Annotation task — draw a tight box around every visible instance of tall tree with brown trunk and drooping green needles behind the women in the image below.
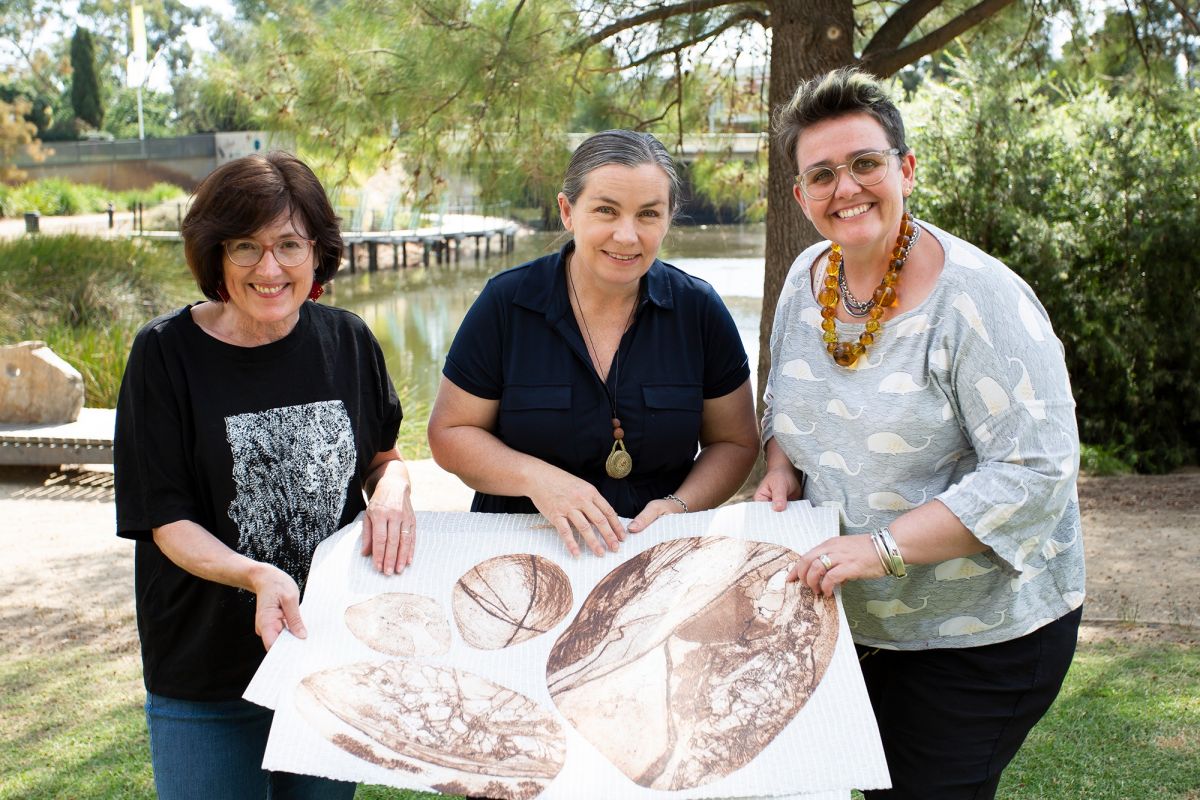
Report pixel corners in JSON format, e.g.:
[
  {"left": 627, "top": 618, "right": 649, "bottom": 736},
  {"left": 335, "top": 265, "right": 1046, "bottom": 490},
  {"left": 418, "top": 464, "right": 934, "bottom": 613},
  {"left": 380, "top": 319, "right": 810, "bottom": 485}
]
[{"left": 218, "top": 0, "right": 1161, "bottom": 410}]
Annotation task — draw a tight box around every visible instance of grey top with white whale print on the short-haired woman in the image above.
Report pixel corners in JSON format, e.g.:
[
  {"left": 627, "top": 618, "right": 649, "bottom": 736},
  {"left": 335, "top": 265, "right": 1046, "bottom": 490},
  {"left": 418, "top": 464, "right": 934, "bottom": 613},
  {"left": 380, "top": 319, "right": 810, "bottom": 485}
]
[{"left": 763, "top": 222, "right": 1084, "bottom": 650}]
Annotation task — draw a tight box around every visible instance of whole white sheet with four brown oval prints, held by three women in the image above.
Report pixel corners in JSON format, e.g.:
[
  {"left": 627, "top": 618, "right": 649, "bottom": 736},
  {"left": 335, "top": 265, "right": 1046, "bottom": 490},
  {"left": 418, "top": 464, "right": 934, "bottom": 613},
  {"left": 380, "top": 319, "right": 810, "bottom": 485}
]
[{"left": 246, "top": 504, "right": 887, "bottom": 800}]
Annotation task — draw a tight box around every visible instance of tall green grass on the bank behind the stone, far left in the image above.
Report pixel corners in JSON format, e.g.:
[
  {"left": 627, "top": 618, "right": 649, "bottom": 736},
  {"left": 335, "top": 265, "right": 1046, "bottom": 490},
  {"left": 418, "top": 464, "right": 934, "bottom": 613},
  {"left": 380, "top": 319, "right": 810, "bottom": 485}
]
[{"left": 0, "top": 235, "right": 196, "bottom": 408}]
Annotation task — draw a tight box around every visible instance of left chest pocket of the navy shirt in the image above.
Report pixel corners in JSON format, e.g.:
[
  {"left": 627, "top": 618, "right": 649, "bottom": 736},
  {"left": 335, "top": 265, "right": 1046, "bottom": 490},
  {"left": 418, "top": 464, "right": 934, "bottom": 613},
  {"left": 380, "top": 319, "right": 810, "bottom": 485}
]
[{"left": 497, "top": 384, "right": 574, "bottom": 464}]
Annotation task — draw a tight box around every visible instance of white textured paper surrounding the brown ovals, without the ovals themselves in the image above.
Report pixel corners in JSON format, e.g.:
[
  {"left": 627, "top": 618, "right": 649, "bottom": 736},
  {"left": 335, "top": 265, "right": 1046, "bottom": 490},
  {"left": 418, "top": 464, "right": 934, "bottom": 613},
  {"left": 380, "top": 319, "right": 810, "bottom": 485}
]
[{"left": 245, "top": 501, "right": 890, "bottom": 800}]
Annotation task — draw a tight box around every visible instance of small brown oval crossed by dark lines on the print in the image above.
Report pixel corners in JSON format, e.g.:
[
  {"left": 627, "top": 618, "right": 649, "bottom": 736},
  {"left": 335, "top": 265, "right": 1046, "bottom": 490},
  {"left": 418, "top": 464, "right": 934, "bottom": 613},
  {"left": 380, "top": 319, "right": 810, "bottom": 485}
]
[{"left": 454, "top": 553, "right": 574, "bottom": 650}]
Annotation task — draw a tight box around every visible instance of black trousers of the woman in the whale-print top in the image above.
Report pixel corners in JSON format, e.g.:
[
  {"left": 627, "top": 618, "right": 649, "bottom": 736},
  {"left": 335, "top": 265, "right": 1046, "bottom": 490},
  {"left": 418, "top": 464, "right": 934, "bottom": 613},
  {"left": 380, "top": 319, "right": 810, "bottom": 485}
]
[{"left": 858, "top": 608, "right": 1082, "bottom": 800}]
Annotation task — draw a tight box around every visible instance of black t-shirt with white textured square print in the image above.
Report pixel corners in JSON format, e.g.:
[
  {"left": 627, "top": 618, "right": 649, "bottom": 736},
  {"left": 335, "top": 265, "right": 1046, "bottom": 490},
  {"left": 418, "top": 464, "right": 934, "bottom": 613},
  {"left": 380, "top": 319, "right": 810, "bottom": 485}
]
[{"left": 114, "top": 302, "right": 402, "bottom": 700}]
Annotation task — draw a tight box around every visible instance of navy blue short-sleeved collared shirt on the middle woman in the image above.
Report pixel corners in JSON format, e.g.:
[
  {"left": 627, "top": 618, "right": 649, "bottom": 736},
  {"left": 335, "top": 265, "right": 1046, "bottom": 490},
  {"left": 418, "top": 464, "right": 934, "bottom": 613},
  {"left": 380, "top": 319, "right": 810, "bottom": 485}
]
[{"left": 443, "top": 242, "right": 750, "bottom": 517}]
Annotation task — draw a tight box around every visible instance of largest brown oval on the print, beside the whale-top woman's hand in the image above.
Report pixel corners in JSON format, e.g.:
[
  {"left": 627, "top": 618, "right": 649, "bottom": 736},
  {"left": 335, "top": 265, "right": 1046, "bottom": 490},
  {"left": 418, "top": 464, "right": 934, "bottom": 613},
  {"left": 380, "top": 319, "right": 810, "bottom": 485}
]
[{"left": 546, "top": 536, "right": 838, "bottom": 790}]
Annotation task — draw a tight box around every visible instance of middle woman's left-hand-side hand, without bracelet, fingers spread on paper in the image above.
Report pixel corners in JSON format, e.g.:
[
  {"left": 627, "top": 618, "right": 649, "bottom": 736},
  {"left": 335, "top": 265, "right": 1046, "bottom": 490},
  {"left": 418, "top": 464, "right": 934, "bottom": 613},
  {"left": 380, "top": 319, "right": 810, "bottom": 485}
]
[{"left": 529, "top": 465, "right": 625, "bottom": 557}]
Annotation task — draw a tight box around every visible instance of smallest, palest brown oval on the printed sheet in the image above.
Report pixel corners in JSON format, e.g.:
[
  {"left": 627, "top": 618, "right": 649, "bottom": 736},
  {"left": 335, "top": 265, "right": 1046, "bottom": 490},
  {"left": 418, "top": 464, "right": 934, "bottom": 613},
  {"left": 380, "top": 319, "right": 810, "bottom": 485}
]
[{"left": 346, "top": 591, "right": 450, "bottom": 657}]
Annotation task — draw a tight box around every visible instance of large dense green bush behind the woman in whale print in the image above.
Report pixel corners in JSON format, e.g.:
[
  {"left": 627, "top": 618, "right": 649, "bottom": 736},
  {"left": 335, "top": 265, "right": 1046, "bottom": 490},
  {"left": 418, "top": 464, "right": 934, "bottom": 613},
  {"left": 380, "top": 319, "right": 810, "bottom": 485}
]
[{"left": 905, "top": 54, "right": 1200, "bottom": 471}]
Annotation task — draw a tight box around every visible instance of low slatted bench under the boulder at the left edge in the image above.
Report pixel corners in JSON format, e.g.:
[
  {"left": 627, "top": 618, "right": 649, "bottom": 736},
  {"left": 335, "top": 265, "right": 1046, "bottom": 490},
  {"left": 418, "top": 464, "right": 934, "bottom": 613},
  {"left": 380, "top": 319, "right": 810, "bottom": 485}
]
[{"left": 0, "top": 408, "right": 116, "bottom": 467}]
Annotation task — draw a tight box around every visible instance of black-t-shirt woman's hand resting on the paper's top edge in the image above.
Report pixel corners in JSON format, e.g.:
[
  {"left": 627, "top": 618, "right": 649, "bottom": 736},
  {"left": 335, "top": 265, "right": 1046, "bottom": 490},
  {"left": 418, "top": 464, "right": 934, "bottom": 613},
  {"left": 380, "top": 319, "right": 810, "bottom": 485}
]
[{"left": 362, "top": 450, "right": 416, "bottom": 575}]
